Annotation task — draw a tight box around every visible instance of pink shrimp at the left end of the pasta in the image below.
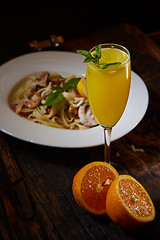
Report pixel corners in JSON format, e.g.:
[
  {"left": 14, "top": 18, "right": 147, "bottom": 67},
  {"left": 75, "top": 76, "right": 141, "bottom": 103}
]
[{"left": 23, "top": 94, "right": 41, "bottom": 108}]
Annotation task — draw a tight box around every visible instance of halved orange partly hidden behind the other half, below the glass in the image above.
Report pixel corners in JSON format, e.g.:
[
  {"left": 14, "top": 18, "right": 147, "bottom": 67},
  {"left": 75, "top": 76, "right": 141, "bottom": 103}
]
[{"left": 72, "top": 161, "right": 119, "bottom": 215}]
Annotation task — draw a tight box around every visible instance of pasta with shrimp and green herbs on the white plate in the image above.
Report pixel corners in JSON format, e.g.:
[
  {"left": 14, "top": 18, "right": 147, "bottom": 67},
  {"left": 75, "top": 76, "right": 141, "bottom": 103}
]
[{"left": 9, "top": 71, "right": 97, "bottom": 130}]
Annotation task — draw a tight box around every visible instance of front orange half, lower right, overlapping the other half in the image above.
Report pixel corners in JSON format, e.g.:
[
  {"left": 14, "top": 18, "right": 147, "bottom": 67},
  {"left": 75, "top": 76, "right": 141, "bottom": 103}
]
[{"left": 106, "top": 175, "right": 155, "bottom": 229}]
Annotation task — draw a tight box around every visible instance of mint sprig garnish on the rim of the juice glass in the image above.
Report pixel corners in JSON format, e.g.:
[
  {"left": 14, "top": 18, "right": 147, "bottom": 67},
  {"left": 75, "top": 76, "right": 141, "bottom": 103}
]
[{"left": 77, "top": 44, "right": 121, "bottom": 69}]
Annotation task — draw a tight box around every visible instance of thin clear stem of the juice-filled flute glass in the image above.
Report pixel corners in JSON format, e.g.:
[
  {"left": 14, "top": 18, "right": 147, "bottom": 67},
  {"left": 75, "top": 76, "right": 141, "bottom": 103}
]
[{"left": 104, "top": 127, "right": 112, "bottom": 164}]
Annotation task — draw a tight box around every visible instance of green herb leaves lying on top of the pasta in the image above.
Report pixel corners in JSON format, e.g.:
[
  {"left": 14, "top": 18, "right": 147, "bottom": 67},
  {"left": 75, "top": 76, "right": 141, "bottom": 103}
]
[{"left": 44, "top": 78, "right": 81, "bottom": 106}]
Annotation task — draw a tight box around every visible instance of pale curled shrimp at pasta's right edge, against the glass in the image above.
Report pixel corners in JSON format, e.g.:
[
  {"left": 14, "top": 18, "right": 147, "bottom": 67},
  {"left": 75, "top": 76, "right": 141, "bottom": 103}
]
[{"left": 78, "top": 101, "right": 98, "bottom": 127}]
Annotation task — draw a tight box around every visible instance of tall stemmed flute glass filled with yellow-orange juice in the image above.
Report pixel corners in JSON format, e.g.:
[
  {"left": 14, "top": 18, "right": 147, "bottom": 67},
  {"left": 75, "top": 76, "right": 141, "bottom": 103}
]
[{"left": 86, "top": 43, "right": 131, "bottom": 164}]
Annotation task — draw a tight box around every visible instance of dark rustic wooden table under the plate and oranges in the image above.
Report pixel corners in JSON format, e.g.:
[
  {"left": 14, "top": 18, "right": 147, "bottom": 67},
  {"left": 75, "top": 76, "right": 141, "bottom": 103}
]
[{"left": 0, "top": 24, "right": 160, "bottom": 240}]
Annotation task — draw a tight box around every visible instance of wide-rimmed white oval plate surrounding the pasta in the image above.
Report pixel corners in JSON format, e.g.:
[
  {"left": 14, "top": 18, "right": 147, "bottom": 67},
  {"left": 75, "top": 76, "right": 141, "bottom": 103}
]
[{"left": 0, "top": 51, "right": 149, "bottom": 148}]
